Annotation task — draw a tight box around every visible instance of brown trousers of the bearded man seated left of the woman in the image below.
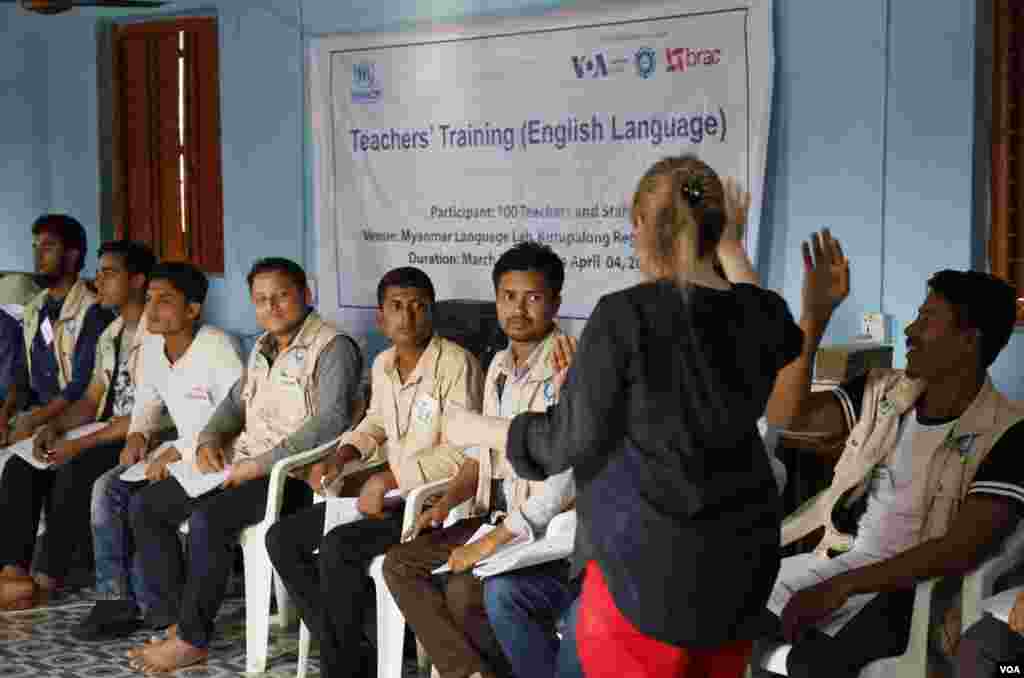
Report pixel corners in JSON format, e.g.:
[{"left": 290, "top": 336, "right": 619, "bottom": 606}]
[{"left": 384, "top": 518, "right": 512, "bottom": 678}]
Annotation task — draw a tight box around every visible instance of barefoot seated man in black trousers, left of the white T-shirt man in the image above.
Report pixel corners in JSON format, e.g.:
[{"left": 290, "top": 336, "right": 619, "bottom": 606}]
[{"left": 0, "top": 241, "right": 155, "bottom": 607}]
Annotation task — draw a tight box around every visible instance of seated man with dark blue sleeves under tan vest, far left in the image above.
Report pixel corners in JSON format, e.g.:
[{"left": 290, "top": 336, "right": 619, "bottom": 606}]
[{"left": 6, "top": 214, "right": 114, "bottom": 443}]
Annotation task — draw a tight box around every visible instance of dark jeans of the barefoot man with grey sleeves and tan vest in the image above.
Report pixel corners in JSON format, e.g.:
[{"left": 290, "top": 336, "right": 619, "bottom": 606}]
[{"left": 129, "top": 477, "right": 312, "bottom": 647}]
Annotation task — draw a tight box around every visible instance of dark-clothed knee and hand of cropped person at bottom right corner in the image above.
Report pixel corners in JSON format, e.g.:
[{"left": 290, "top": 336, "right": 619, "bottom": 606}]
[{"left": 955, "top": 570, "right": 1024, "bottom": 678}]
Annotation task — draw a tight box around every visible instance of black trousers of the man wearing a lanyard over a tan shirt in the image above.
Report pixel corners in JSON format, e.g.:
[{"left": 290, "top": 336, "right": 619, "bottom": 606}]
[{"left": 266, "top": 504, "right": 402, "bottom": 678}]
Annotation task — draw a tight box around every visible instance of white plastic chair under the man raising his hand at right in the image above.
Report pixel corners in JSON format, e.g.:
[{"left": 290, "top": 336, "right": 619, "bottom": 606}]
[{"left": 751, "top": 522, "right": 1024, "bottom": 678}]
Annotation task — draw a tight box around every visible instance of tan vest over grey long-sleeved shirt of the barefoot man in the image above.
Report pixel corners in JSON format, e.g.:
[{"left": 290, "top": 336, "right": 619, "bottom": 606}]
[{"left": 231, "top": 310, "right": 341, "bottom": 457}]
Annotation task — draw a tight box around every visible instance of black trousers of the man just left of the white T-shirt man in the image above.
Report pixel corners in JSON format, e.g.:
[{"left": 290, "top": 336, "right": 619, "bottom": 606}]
[{"left": 0, "top": 442, "right": 122, "bottom": 579}]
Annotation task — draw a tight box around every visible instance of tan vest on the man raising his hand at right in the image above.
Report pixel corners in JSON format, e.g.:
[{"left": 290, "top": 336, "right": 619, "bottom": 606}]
[{"left": 781, "top": 370, "right": 1024, "bottom": 557}]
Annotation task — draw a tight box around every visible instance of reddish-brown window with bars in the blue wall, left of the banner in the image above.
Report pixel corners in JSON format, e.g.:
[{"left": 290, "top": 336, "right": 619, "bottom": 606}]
[{"left": 113, "top": 17, "right": 224, "bottom": 273}]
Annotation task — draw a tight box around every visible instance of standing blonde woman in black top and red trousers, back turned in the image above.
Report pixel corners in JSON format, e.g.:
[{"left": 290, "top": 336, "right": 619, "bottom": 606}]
[{"left": 450, "top": 156, "right": 803, "bottom": 678}]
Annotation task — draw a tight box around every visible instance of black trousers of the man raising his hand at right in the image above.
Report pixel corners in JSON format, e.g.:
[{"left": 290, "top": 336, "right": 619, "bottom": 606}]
[{"left": 754, "top": 589, "right": 913, "bottom": 678}]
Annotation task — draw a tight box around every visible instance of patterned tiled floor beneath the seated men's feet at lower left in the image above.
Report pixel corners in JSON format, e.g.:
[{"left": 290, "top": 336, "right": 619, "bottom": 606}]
[{"left": 0, "top": 594, "right": 416, "bottom": 678}]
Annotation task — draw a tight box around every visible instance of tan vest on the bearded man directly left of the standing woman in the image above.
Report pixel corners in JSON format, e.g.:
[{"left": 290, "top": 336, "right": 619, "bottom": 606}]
[{"left": 473, "top": 327, "right": 562, "bottom": 514}]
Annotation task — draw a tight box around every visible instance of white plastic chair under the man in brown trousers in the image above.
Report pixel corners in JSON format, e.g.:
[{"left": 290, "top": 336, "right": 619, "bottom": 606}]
[{"left": 297, "top": 478, "right": 471, "bottom": 678}]
